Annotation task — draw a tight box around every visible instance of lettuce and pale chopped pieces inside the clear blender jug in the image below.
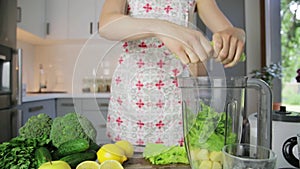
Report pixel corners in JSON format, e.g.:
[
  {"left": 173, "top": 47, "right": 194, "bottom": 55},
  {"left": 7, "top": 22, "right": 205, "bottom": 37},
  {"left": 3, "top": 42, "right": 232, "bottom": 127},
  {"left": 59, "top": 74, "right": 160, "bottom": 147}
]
[{"left": 185, "top": 103, "right": 237, "bottom": 169}]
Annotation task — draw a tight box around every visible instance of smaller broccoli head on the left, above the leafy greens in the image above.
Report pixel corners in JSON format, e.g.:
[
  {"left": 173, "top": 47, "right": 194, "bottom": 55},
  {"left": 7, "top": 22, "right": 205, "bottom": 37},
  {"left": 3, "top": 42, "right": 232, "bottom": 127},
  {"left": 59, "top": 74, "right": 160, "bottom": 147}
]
[{"left": 19, "top": 113, "right": 53, "bottom": 144}]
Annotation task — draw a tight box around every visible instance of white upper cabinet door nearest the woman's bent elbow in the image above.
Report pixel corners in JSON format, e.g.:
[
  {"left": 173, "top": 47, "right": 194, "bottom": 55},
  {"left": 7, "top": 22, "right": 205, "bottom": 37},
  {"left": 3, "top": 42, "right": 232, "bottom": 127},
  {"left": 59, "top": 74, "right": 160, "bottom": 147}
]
[{"left": 68, "top": 0, "right": 96, "bottom": 39}]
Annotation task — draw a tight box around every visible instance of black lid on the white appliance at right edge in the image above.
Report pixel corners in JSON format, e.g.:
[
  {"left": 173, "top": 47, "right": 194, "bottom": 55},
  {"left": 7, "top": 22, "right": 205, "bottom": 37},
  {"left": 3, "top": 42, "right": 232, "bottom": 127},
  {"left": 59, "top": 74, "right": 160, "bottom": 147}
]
[{"left": 273, "top": 106, "right": 300, "bottom": 122}]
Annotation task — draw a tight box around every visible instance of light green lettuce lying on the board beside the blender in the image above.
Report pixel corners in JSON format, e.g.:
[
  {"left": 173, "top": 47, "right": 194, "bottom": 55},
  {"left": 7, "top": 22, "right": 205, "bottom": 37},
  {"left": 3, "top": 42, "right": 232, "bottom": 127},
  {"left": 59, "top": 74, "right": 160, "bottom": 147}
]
[{"left": 143, "top": 143, "right": 189, "bottom": 164}]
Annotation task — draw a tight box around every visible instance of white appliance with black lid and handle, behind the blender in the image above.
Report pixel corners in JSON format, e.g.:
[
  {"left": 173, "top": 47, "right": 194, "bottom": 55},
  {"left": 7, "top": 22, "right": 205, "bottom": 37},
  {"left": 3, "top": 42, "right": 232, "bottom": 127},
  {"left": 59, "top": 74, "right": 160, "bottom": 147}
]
[{"left": 249, "top": 106, "right": 300, "bottom": 168}]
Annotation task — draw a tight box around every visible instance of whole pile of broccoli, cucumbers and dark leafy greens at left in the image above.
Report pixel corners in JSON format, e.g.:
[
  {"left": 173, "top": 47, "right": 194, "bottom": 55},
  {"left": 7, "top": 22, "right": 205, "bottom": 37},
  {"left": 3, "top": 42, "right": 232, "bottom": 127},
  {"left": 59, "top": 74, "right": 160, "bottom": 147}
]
[{"left": 0, "top": 113, "right": 99, "bottom": 169}]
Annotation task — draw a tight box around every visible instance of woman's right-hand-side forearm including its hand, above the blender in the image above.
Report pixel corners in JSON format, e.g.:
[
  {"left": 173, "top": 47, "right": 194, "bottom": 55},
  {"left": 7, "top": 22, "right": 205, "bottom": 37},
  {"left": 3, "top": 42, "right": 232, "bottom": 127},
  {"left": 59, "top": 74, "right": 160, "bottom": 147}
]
[{"left": 196, "top": 0, "right": 245, "bottom": 67}]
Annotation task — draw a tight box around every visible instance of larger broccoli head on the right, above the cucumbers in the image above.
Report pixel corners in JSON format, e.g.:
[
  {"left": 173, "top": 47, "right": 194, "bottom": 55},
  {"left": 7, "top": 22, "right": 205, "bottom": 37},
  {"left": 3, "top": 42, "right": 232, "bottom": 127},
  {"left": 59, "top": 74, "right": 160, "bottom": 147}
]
[{"left": 50, "top": 112, "right": 97, "bottom": 148}]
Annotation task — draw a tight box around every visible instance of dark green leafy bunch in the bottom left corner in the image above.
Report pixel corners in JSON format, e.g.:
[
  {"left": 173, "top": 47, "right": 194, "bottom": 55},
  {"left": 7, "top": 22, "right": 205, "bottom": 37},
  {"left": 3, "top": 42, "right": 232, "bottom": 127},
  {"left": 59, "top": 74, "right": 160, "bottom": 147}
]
[{"left": 0, "top": 136, "right": 41, "bottom": 169}]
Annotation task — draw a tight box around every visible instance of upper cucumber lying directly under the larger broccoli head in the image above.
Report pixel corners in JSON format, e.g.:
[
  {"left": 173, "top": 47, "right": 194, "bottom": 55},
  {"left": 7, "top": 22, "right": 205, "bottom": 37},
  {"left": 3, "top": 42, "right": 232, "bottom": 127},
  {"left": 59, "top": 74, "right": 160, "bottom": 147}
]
[{"left": 53, "top": 138, "right": 90, "bottom": 159}]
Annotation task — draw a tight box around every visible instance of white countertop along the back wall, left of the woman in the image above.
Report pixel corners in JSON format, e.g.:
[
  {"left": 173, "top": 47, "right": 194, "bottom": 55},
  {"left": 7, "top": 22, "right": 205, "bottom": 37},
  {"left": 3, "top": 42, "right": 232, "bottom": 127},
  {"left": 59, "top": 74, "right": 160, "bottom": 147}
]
[{"left": 22, "top": 93, "right": 110, "bottom": 103}]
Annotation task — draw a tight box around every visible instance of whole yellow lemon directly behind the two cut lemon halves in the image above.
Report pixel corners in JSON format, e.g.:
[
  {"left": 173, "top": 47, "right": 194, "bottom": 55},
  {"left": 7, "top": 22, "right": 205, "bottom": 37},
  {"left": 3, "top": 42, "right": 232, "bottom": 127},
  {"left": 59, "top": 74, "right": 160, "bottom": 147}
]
[{"left": 97, "top": 144, "right": 127, "bottom": 164}]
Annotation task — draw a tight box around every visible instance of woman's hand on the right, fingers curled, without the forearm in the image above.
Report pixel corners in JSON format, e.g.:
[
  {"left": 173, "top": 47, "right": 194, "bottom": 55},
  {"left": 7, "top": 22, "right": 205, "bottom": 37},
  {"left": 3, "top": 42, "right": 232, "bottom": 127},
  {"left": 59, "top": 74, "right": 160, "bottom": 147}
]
[{"left": 212, "top": 27, "right": 245, "bottom": 68}]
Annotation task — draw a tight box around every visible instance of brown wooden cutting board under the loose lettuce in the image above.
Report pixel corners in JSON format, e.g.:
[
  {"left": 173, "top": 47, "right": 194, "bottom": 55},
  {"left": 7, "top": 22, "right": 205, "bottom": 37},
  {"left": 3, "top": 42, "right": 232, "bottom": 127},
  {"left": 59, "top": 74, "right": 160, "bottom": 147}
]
[{"left": 123, "top": 153, "right": 191, "bottom": 169}]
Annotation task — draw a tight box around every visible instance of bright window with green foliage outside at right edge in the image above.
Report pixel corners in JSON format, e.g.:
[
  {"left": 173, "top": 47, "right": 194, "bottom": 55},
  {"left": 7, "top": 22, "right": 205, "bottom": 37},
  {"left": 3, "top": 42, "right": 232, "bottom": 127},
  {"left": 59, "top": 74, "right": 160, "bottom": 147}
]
[{"left": 280, "top": 0, "right": 300, "bottom": 112}]
